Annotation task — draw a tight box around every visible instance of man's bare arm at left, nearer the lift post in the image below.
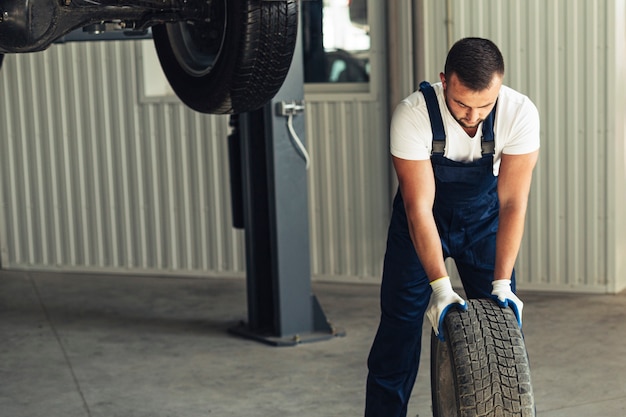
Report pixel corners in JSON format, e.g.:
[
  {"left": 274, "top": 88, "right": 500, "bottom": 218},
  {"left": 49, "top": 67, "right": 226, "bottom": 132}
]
[{"left": 393, "top": 156, "right": 448, "bottom": 281}]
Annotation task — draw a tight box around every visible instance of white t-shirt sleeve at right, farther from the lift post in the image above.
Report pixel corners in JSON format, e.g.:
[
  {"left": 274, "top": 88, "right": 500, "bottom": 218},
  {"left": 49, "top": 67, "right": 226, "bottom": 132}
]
[{"left": 502, "top": 98, "right": 540, "bottom": 155}]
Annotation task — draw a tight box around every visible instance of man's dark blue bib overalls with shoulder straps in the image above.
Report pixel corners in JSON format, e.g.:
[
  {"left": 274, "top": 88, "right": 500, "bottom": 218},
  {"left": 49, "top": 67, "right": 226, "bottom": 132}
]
[{"left": 365, "top": 82, "right": 515, "bottom": 417}]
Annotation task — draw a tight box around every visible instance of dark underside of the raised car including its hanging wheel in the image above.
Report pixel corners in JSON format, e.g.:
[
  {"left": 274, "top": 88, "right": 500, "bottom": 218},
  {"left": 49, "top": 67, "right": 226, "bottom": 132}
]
[{"left": 0, "top": 0, "right": 298, "bottom": 113}]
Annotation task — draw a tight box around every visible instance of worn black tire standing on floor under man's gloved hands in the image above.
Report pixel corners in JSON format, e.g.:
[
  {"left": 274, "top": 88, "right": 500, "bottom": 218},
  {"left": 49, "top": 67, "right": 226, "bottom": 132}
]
[{"left": 431, "top": 299, "right": 535, "bottom": 417}]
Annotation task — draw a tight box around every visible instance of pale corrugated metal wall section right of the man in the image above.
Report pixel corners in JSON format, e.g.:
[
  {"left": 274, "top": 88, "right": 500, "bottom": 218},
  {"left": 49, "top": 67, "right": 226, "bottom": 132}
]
[{"left": 418, "top": 0, "right": 626, "bottom": 291}]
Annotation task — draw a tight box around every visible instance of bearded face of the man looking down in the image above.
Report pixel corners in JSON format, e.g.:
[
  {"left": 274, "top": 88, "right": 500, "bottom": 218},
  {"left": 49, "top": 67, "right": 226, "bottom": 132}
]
[{"left": 439, "top": 73, "right": 502, "bottom": 130}]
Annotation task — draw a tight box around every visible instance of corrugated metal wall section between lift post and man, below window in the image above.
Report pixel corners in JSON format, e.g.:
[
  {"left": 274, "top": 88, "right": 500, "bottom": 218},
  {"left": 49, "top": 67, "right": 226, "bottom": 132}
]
[{"left": 307, "top": 99, "right": 390, "bottom": 282}]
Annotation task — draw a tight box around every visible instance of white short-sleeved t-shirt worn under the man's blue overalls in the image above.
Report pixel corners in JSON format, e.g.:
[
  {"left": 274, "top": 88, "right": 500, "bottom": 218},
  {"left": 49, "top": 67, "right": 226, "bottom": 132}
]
[{"left": 390, "top": 83, "right": 539, "bottom": 176}]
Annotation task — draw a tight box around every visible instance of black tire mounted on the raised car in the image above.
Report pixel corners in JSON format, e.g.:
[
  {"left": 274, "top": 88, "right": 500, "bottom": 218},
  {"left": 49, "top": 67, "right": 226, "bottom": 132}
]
[{"left": 152, "top": 0, "right": 298, "bottom": 114}]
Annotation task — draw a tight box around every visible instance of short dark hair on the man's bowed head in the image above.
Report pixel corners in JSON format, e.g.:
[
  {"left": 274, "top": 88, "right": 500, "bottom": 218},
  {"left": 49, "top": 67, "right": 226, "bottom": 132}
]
[{"left": 444, "top": 38, "right": 504, "bottom": 91}]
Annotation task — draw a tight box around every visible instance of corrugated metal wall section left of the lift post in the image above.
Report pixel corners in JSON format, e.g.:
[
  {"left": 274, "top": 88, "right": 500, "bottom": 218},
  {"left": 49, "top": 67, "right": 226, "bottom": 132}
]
[{"left": 0, "top": 41, "right": 244, "bottom": 275}]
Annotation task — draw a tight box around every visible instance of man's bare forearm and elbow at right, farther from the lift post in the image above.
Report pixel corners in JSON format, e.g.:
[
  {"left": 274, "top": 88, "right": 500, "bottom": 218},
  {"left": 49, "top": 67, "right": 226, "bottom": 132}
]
[{"left": 494, "top": 150, "right": 539, "bottom": 280}]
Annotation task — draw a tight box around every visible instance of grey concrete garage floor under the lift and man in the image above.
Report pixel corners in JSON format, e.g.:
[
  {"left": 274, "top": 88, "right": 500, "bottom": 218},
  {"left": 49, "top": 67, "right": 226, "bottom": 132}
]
[{"left": 0, "top": 271, "right": 626, "bottom": 417}]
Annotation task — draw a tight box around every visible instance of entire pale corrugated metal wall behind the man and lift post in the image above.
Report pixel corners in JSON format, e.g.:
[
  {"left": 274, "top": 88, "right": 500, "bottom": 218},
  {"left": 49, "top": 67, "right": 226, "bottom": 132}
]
[{"left": 0, "top": 0, "right": 626, "bottom": 292}]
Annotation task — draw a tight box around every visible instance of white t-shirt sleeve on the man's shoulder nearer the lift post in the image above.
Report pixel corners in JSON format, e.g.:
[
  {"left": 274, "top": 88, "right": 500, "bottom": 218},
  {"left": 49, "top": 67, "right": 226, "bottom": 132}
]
[{"left": 390, "top": 100, "right": 432, "bottom": 161}]
